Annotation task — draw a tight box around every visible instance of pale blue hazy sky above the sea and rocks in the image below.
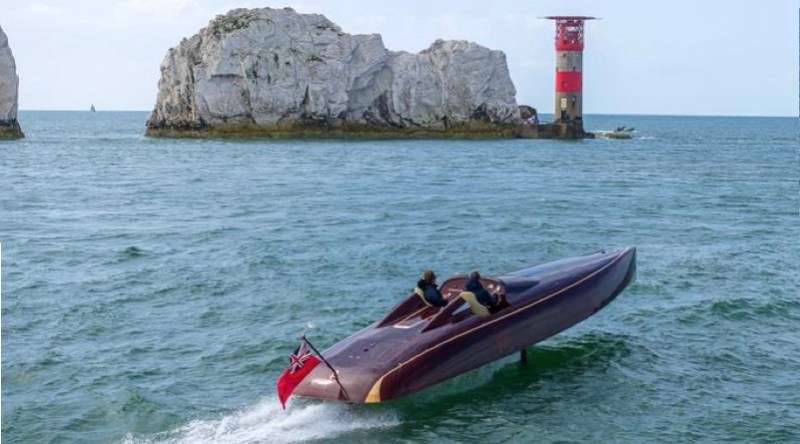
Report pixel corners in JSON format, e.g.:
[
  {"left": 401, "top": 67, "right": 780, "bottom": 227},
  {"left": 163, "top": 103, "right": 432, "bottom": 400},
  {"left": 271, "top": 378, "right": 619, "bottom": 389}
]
[{"left": 0, "top": 0, "right": 800, "bottom": 116}]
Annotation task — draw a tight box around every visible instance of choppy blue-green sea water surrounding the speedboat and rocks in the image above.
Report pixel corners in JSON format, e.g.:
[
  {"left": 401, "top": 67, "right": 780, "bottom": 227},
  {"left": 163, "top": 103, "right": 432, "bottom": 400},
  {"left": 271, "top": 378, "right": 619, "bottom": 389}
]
[{"left": 0, "top": 112, "right": 800, "bottom": 443}]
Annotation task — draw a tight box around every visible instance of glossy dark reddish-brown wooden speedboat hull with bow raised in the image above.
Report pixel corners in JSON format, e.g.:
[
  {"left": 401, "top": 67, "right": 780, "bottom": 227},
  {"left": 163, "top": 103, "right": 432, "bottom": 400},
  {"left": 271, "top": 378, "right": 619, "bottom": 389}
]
[{"left": 295, "top": 247, "right": 636, "bottom": 402}]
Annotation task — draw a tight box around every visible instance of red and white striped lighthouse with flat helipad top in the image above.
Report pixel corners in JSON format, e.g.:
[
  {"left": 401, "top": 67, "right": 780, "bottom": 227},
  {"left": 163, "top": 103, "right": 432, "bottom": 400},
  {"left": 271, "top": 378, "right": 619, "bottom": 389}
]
[{"left": 545, "top": 16, "right": 595, "bottom": 130}]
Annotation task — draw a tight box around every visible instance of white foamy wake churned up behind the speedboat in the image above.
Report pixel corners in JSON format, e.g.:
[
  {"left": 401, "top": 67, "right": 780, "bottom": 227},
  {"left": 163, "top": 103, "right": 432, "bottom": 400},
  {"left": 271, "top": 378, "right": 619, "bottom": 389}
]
[{"left": 123, "top": 397, "right": 400, "bottom": 444}]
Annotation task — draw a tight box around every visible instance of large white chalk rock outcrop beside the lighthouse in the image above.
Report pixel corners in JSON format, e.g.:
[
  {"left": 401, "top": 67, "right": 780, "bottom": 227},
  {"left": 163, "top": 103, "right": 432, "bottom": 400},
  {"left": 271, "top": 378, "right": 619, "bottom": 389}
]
[{"left": 147, "top": 8, "right": 520, "bottom": 137}]
